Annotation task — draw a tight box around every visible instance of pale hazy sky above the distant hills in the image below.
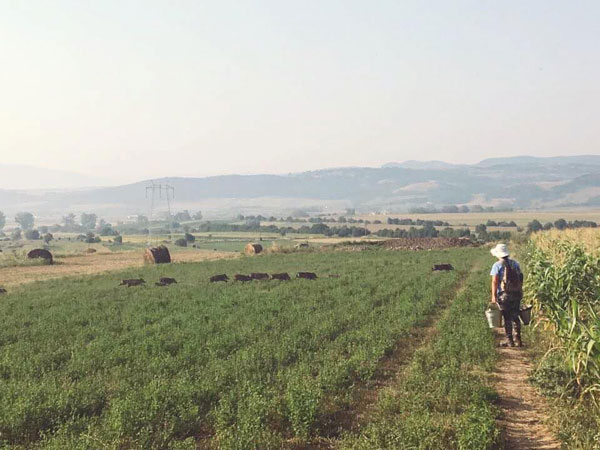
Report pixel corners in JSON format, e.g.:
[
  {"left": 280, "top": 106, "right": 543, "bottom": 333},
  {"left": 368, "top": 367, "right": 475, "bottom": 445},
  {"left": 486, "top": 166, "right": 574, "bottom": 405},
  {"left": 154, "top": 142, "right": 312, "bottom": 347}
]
[{"left": 0, "top": 0, "right": 600, "bottom": 185}]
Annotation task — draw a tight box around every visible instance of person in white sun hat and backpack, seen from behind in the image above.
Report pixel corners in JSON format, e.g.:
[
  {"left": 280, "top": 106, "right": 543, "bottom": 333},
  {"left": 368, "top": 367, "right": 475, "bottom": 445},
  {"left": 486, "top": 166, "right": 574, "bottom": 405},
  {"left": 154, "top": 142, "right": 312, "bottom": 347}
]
[{"left": 490, "top": 244, "right": 523, "bottom": 347}]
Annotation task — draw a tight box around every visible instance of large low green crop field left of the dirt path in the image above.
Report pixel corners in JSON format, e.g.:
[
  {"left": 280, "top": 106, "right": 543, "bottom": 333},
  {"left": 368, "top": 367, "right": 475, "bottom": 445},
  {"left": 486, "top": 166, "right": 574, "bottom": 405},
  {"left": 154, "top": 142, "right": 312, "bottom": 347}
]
[{"left": 0, "top": 248, "right": 496, "bottom": 449}]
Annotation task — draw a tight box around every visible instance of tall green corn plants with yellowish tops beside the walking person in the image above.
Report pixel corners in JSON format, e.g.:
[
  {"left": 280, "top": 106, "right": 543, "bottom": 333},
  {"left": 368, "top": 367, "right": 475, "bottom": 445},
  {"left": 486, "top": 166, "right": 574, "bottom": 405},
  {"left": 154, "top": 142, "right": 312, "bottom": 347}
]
[{"left": 525, "top": 230, "right": 600, "bottom": 407}]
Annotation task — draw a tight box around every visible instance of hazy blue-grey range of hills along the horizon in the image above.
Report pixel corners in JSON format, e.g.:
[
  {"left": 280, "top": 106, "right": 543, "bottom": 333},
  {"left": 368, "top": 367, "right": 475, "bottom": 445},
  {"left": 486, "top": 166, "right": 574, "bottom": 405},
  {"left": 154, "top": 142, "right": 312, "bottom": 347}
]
[{"left": 0, "top": 155, "right": 600, "bottom": 217}]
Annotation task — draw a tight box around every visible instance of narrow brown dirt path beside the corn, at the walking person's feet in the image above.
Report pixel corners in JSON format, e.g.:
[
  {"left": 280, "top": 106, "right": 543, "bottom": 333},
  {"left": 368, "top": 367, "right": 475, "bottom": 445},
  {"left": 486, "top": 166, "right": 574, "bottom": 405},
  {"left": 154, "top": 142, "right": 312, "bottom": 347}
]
[{"left": 494, "top": 328, "right": 561, "bottom": 450}]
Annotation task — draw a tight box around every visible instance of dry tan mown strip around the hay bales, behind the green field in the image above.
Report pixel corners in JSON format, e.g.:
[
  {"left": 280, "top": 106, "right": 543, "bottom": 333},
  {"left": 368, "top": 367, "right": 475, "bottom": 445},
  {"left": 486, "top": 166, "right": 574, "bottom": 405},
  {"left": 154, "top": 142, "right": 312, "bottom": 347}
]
[{"left": 0, "top": 250, "right": 238, "bottom": 287}]
